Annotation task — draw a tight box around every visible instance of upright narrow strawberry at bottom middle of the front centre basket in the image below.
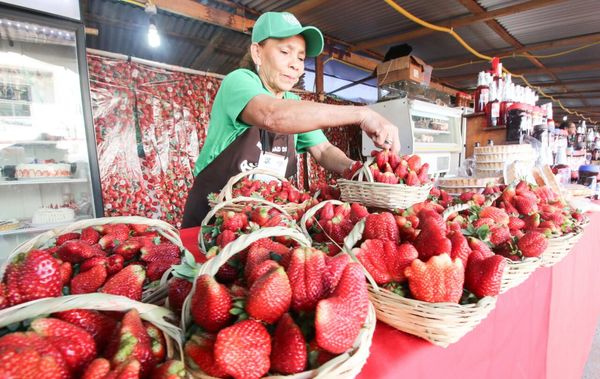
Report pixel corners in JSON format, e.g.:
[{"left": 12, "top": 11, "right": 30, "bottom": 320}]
[{"left": 271, "top": 313, "right": 307, "bottom": 375}]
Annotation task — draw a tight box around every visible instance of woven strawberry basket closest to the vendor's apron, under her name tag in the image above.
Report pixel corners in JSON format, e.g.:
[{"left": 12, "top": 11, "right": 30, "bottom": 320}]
[{"left": 208, "top": 168, "right": 313, "bottom": 219}]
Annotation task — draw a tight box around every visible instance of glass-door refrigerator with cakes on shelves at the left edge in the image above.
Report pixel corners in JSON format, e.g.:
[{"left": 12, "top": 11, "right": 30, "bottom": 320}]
[{"left": 0, "top": 0, "right": 102, "bottom": 262}]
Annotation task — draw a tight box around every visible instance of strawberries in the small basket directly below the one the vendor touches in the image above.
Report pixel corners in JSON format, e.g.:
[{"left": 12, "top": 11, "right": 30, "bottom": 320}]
[{"left": 305, "top": 202, "right": 369, "bottom": 255}]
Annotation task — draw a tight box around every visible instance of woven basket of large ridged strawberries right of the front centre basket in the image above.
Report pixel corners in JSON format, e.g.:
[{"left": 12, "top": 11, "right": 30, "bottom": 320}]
[{"left": 344, "top": 204, "right": 506, "bottom": 347}]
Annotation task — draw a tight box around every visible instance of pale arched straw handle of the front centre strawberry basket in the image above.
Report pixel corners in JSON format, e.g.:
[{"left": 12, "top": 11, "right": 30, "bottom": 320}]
[{"left": 181, "top": 226, "right": 310, "bottom": 333}]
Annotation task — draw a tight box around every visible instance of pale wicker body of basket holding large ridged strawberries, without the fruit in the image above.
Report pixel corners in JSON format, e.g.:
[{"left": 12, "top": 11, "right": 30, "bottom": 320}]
[{"left": 344, "top": 214, "right": 496, "bottom": 347}]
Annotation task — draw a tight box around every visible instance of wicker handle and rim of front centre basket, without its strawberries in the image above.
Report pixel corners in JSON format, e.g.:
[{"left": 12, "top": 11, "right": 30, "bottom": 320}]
[{"left": 181, "top": 227, "right": 375, "bottom": 379}]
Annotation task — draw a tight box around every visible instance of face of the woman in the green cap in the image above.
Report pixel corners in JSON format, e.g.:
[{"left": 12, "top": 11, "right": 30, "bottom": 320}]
[{"left": 251, "top": 35, "right": 306, "bottom": 96}]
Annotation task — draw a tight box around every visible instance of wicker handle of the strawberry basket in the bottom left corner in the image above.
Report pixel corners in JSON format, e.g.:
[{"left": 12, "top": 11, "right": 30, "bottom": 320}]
[{"left": 0, "top": 293, "right": 183, "bottom": 359}]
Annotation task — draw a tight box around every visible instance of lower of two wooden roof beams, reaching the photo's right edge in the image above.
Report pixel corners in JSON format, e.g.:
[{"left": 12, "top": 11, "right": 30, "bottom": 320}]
[{"left": 431, "top": 33, "right": 600, "bottom": 69}]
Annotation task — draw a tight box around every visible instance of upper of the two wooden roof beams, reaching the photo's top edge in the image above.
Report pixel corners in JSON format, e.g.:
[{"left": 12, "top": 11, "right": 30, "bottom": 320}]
[{"left": 356, "top": 0, "right": 565, "bottom": 50}]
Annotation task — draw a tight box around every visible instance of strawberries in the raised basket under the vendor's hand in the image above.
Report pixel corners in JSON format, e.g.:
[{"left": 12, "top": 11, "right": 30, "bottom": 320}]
[{"left": 369, "top": 150, "right": 430, "bottom": 186}]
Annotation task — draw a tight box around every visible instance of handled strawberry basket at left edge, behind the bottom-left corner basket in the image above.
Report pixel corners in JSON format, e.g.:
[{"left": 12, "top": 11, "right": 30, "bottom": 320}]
[{"left": 0, "top": 216, "right": 185, "bottom": 309}]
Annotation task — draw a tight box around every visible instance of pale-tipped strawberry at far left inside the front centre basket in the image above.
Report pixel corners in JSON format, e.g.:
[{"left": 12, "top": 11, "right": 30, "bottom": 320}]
[{"left": 191, "top": 274, "right": 232, "bottom": 332}]
